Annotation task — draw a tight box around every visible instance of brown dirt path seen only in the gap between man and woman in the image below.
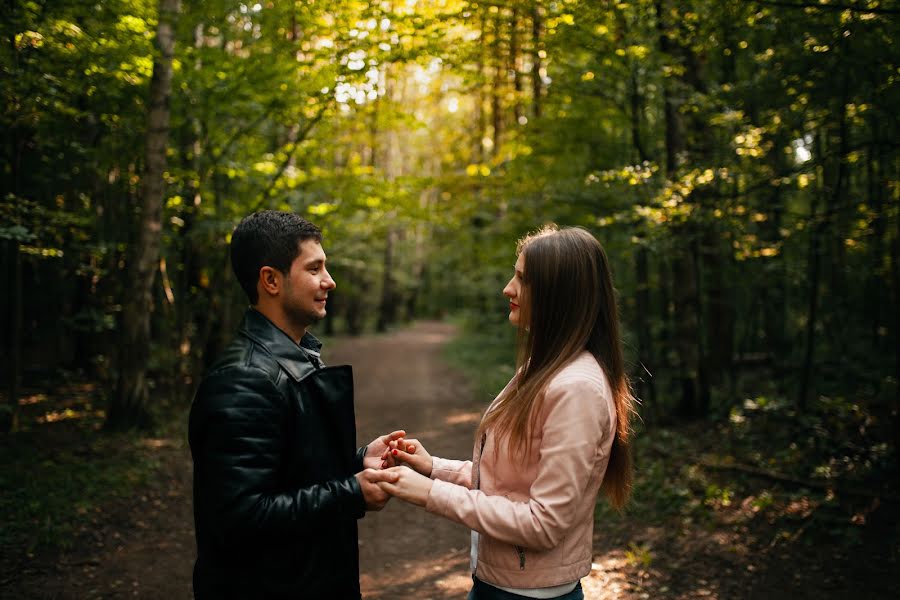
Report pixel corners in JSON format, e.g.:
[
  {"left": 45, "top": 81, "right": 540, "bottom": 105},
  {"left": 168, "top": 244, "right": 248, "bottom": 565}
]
[{"left": 325, "top": 322, "right": 484, "bottom": 600}]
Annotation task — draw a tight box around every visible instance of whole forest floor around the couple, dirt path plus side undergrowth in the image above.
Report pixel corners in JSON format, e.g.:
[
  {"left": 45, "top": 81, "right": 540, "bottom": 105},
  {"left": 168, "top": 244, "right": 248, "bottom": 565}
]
[{"left": 0, "top": 322, "right": 900, "bottom": 600}]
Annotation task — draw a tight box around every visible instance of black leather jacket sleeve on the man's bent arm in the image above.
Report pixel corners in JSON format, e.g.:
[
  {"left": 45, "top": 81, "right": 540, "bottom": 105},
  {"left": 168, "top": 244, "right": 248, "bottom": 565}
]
[{"left": 189, "top": 367, "right": 365, "bottom": 541}]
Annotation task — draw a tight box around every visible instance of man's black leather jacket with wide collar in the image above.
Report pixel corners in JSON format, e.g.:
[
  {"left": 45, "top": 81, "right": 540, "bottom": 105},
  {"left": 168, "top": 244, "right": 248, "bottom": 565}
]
[{"left": 189, "top": 309, "right": 365, "bottom": 600}]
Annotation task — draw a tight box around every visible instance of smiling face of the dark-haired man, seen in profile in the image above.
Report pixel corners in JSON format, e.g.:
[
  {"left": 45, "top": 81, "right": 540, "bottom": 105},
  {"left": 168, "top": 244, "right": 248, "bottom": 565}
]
[{"left": 281, "top": 240, "right": 335, "bottom": 329}]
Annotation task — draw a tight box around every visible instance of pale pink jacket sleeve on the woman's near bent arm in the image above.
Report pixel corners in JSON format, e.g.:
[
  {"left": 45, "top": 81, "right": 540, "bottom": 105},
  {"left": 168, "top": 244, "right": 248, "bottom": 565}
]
[{"left": 425, "top": 380, "right": 612, "bottom": 550}]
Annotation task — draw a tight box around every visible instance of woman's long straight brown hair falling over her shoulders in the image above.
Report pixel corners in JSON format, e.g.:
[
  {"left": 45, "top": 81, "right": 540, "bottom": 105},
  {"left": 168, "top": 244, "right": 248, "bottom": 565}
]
[{"left": 476, "top": 225, "right": 635, "bottom": 508}]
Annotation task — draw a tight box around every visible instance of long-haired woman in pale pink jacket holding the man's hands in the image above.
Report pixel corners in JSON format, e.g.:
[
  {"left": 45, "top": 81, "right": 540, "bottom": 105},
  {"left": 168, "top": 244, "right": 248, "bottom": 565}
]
[{"left": 379, "top": 227, "right": 633, "bottom": 600}]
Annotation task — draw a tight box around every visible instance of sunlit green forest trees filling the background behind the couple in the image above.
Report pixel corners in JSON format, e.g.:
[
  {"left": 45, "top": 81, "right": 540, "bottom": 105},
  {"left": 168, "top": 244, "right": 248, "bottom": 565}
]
[{"left": 0, "top": 0, "right": 900, "bottom": 460}]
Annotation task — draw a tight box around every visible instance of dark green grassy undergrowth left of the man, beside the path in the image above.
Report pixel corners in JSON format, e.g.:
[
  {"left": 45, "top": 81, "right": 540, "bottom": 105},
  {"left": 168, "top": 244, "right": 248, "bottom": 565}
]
[{"left": 0, "top": 381, "right": 165, "bottom": 560}]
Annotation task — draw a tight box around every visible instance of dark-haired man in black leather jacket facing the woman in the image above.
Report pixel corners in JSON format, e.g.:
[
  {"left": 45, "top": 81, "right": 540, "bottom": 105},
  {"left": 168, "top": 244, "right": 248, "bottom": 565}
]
[{"left": 189, "top": 211, "right": 404, "bottom": 600}]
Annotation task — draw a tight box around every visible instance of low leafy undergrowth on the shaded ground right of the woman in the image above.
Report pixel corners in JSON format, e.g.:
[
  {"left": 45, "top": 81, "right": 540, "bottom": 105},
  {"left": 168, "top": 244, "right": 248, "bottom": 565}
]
[{"left": 595, "top": 398, "right": 897, "bottom": 550}]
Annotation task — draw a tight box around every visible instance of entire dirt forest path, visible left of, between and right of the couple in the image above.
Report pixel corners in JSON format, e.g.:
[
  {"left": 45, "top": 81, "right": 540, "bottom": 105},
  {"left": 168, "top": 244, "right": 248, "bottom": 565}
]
[{"left": 17, "top": 322, "right": 628, "bottom": 600}]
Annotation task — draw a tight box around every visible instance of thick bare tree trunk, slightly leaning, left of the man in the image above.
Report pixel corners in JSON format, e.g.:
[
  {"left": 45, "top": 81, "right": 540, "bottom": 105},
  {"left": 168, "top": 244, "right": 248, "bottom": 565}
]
[{"left": 107, "top": 0, "right": 180, "bottom": 429}]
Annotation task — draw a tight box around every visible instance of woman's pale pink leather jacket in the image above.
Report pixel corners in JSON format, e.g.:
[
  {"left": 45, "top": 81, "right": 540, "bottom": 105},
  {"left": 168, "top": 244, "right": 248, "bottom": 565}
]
[{"left": 425, "top": 352, "right": 616, "bottom": 588}]
